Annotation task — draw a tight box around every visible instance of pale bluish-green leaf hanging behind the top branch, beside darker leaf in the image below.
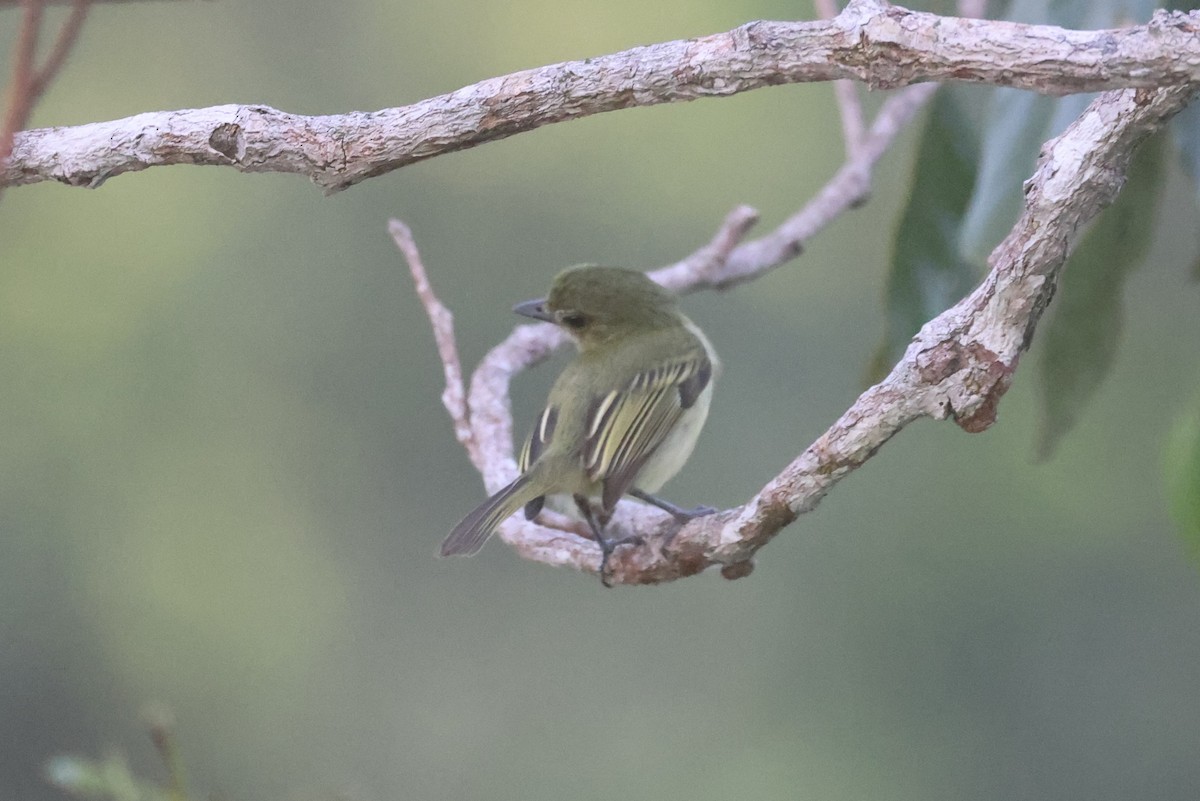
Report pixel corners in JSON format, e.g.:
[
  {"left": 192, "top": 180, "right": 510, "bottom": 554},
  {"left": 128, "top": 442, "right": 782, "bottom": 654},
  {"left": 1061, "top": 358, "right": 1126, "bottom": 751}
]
[{"left": 960, "top": 0, "right": 1156, "bottom": 266}]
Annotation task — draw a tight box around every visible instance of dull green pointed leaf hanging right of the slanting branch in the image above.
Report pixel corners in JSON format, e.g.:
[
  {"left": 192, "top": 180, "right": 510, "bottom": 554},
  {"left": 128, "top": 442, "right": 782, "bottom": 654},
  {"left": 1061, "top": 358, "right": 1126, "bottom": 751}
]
[{"left": 1037, "top": 130, "right": 1165, "bottom": 459}]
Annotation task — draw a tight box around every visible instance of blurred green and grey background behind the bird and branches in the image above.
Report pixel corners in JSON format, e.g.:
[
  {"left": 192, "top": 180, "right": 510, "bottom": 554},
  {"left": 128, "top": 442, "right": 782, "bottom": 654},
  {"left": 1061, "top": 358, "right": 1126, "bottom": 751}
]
[{"left": 0, "top": 0, "right": 1200, "bottom": 801}]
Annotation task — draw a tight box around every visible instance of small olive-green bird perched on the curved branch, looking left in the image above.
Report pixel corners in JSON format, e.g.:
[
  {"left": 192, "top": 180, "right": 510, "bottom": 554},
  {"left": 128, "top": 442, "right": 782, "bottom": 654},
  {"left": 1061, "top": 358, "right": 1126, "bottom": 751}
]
[{"left": 442, "top": 265, "right": 719, "bottom": 577}]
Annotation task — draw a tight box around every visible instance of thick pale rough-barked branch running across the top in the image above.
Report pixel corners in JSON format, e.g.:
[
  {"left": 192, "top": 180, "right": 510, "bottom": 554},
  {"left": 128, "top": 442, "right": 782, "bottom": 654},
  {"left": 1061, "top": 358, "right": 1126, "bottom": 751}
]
[{"left": 9, "top": 0, "right": 1200, "bottom": 192}]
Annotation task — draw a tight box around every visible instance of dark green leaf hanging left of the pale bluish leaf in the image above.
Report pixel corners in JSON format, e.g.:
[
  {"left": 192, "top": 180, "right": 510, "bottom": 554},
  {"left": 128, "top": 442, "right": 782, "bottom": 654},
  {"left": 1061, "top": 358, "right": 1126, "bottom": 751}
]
[{"left": 869, "top": 88, "right": 977, "bottom": 383}]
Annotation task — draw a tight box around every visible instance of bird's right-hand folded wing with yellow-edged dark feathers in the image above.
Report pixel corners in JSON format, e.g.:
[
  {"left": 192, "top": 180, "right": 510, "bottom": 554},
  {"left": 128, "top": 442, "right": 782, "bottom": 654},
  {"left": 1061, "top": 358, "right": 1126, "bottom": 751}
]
[{"left": 583, "top": 351, "right": 713, "bottom": 510}]
